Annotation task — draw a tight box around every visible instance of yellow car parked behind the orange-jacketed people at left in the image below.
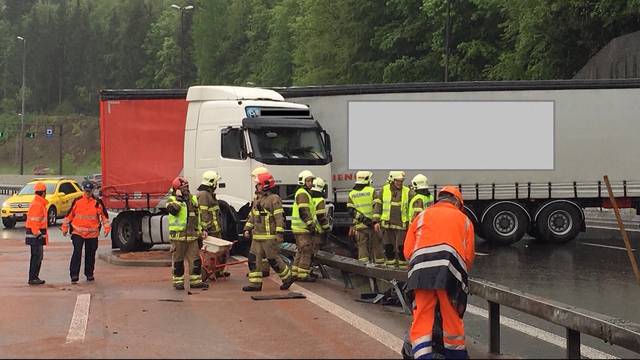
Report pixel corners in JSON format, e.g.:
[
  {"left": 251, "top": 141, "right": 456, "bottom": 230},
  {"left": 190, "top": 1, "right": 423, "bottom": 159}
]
[{"left": 2, "top": 178, "right": 82, "bottom": 229}]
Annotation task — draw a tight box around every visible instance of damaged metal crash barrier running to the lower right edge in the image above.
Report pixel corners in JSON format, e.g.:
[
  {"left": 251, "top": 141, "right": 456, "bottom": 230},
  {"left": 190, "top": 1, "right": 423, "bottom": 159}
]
[{"left": 282, "top": 244, "right": 640, "bottom": 359}]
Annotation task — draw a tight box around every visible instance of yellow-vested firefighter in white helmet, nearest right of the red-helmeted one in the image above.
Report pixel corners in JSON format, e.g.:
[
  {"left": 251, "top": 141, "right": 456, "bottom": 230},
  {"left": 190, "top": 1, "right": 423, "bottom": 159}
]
[{"left": 291, "top": 170, "right": 316, "bottom": 282}]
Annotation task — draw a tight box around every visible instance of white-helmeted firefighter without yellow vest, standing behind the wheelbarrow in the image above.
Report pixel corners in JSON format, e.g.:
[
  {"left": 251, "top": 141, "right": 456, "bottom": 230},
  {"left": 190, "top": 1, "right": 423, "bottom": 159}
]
[{"left": 197, "top": 170, "right": 231, "bottom": 277}]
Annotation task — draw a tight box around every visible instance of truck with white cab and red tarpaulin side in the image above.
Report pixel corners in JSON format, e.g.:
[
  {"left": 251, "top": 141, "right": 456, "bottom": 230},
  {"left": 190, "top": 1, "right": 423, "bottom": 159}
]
[{"left": 100, "top": 86, "right": 332, "bottom": 252}]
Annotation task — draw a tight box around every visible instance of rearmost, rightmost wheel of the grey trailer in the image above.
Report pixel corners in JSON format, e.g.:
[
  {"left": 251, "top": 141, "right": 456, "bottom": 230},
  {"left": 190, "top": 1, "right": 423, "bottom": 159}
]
[{"left": 537, "top": 202, "right": 582, "bottom": 243}]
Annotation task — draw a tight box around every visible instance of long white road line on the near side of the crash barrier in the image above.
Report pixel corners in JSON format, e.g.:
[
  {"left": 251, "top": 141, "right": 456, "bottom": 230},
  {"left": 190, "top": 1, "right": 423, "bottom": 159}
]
[{"left": 271, "top": 277, "right": 404, "bottom": 354}]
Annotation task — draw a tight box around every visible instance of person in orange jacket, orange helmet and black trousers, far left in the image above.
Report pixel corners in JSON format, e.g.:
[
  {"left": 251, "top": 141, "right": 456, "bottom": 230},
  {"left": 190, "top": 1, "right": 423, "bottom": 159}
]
[{"left": 24, "top": 182, "right": 49, "bottom": 285}]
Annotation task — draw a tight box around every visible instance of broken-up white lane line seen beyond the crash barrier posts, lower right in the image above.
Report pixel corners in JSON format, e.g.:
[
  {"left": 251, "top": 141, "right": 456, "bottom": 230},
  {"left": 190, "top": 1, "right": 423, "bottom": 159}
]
[{"left": 467, "top": 304, "right": 617, "bottom": 359}]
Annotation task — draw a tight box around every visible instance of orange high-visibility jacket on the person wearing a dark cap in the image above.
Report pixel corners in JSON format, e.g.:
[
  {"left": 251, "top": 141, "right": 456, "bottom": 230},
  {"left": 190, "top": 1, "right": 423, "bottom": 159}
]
[{"left": 61, "top": 194, "right": 110, "bottom": 239}]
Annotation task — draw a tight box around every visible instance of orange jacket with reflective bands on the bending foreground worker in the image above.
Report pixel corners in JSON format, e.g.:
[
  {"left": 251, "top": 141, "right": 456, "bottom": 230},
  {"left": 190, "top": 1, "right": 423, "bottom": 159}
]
[{"left": 404, "top": 202, "right": 475, "bottom": 314}]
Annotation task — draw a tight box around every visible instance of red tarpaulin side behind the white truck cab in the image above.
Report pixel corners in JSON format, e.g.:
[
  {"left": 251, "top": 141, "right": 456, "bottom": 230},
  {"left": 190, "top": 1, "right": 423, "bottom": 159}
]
[{"left": 100, "top": 99, "right": 187, "bottom": 209}]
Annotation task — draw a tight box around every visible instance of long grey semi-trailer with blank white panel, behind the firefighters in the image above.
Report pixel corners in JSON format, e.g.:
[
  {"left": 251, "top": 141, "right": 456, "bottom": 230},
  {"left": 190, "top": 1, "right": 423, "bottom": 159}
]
[{"left": 277, "top": 79, "right": 640, "bottom": 245}]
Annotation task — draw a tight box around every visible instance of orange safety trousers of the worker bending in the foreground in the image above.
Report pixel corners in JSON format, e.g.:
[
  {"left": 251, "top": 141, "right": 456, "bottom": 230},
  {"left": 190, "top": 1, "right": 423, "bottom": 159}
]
[{"left": 409, "top": 289, "right": 469, "bottom": 359}]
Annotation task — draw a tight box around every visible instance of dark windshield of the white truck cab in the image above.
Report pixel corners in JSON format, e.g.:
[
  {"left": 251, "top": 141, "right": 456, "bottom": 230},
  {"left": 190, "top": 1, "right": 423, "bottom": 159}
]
[{"left": 249, "top": 127, "right": 329, "bottom": 165}]
